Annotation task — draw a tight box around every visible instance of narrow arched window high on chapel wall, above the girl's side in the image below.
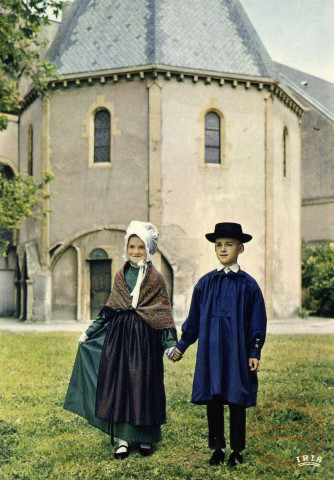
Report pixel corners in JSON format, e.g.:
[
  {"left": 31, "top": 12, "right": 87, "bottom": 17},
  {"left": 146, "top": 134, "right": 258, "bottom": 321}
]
[{"left": 94, "top": 109, "right": 110, "bottom": 163}]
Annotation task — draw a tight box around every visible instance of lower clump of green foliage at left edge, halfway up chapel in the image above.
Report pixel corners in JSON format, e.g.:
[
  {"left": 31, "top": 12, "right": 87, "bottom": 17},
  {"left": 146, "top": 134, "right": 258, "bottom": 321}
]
[{"left": 0, "top": 165, "right": 53, "bottom": 256}]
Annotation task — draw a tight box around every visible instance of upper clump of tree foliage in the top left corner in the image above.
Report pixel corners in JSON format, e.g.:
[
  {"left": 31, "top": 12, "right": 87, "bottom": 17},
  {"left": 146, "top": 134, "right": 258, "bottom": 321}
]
[{"left": 0, "top": 0, "right": 62, "bottom": 131}]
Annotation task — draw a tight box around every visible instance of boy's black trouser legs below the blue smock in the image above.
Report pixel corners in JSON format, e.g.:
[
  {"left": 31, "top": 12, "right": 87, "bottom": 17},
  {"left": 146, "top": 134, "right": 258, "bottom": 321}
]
[{"left": 207, "top": 395, "right": 246, "bottom": 452}]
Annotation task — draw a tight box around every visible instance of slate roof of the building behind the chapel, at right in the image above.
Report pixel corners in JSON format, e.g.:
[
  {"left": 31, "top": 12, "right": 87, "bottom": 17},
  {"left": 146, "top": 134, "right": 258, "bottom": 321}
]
[{"left": 275, "top": 63, "right": 334, "bottom": 121}]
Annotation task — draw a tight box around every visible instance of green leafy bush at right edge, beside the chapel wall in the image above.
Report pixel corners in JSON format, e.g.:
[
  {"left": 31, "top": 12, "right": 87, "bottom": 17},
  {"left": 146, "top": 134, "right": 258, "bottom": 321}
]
[{"left": 302, "top": 242, "right": 334, "bottom": 317}]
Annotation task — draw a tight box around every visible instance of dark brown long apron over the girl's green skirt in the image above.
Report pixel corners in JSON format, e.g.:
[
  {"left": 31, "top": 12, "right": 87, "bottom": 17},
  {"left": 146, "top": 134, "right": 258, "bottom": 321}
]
[{"left": 95, "top": 310, "right": 166, "bottom": 426}]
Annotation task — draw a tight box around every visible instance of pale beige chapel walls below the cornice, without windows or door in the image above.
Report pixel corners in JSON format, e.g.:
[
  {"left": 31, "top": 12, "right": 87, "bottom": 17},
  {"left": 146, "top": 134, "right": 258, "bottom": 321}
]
[{"left": 9, "top": 75, "right": 301, "bottom": 321}]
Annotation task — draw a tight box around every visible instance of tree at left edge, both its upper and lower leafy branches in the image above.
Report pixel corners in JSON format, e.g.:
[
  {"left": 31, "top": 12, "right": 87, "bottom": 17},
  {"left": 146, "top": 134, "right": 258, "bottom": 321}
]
[{"left": 0, "top": 0, "right": 62, "bottom": 256}]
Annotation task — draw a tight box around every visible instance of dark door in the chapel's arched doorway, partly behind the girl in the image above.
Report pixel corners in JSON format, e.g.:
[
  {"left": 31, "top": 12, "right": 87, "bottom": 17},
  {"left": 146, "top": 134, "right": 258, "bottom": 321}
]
[{"left": 89, "top": 260, "right": 111, "bottom": 319}]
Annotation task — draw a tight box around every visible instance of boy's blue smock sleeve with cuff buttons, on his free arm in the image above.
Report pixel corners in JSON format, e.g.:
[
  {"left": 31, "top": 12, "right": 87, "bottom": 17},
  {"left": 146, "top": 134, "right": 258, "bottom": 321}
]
[{"left": 248, "top": 285, "right": 267, "bottom": 360}]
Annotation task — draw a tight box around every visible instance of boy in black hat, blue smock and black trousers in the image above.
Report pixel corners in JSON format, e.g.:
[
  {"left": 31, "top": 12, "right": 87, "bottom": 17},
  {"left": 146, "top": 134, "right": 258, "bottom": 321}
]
[{"left": 172, "top": 223, "right": 267, "bottom": 467}]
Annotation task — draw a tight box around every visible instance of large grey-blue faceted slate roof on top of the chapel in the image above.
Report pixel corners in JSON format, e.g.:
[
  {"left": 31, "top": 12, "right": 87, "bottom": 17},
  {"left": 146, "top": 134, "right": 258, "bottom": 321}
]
[{"left": 48, "top": 0, "right": 276, "bottom": 77}]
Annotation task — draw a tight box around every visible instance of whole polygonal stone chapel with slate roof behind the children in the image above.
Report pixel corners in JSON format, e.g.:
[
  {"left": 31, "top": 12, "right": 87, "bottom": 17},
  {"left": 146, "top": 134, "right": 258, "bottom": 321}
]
[{"left": 0, "top": 0, "right": 303, "bottom": 321}]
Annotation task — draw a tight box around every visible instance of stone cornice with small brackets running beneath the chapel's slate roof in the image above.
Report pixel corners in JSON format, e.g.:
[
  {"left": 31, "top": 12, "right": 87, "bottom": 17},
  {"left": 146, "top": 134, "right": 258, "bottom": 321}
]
[{"left": 22, "top": 65, "right": 304, "bottom": 116}]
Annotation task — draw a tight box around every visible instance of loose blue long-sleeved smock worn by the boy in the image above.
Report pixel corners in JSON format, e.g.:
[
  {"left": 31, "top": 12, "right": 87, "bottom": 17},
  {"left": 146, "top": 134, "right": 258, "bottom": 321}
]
[{"left": 177, "top": 270, "right": 267, "bottom": 407}]
